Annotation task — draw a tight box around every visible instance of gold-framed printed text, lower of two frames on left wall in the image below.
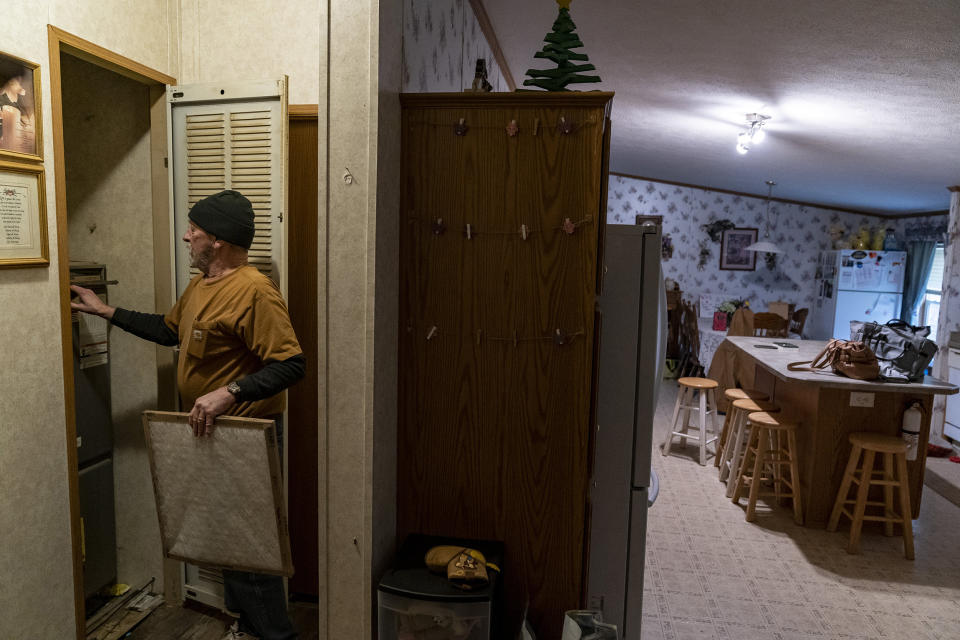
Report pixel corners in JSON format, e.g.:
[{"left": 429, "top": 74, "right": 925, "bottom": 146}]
[{"left": 0, "top": 159, "right": 50, "bottom": 268}]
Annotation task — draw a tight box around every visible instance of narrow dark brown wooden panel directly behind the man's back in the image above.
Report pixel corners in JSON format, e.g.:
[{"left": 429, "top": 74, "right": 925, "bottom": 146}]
[{"left": 287, "top": 105, "right": 319, "bottom": 598}]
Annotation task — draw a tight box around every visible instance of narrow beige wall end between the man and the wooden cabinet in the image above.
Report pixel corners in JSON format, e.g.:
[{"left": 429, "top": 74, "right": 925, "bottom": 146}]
[{"left": 318, "top": 0, "right": 402, "bottom": 638}]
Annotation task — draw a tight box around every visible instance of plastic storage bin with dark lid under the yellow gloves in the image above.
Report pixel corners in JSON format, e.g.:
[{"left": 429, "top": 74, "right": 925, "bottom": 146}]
[{"left": 377, "top": 535, "right": 503, "bottom": 640}]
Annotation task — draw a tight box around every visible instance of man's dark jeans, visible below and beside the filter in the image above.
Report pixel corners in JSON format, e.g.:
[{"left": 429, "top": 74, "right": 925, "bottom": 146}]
[{"left": 223, "top": 416, "right": 297, "bottom": 640}]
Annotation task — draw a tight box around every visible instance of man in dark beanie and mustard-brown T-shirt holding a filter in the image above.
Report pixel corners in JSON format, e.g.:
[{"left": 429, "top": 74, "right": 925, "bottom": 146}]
[{"left": 70, "top": 190, "right": 305, "bottom": 640}]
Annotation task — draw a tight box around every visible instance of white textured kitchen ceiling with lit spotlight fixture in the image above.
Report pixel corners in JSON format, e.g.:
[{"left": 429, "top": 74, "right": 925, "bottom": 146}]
[{"left": 484, "top": 0, "right": 960, "bottom": 215}]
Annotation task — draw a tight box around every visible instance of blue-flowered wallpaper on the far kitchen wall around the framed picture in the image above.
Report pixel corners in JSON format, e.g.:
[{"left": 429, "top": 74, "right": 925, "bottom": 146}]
[{"left": 607, "top": 175, "right": 946, "bottom": 320}]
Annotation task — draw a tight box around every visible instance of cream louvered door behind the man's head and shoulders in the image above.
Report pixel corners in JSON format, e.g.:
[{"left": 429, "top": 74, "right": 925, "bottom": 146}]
[{"left": 167, "top": 77, "right": 287, "bottom": 296}]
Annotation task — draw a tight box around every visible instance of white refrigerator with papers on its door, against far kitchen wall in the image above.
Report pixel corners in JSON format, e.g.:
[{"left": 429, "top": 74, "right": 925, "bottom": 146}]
[{"left": 807, "top": 249, "right": 907, "bottom": 340}]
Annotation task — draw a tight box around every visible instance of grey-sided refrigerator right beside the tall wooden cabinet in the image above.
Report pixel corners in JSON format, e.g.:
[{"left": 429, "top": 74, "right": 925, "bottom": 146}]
[{"left": 587, "top": 216, "right": 667, "bottom": 640}]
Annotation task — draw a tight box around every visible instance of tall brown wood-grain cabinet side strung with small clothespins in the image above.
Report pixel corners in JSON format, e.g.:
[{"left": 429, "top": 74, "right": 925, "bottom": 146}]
[{"left": 397, "top": 92, "right": 612, "bottom": 638}]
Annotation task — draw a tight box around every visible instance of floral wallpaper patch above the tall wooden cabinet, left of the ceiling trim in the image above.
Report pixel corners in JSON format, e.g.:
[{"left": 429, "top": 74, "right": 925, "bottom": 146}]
[{"left": 403, "top": 0, "right": 508, "bottom": 93}]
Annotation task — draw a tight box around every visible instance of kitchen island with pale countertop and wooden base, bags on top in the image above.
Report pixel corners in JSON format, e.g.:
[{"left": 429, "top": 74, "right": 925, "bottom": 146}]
[{"left": 726, "top": 336, "right": 960, "bottom": 526}]
